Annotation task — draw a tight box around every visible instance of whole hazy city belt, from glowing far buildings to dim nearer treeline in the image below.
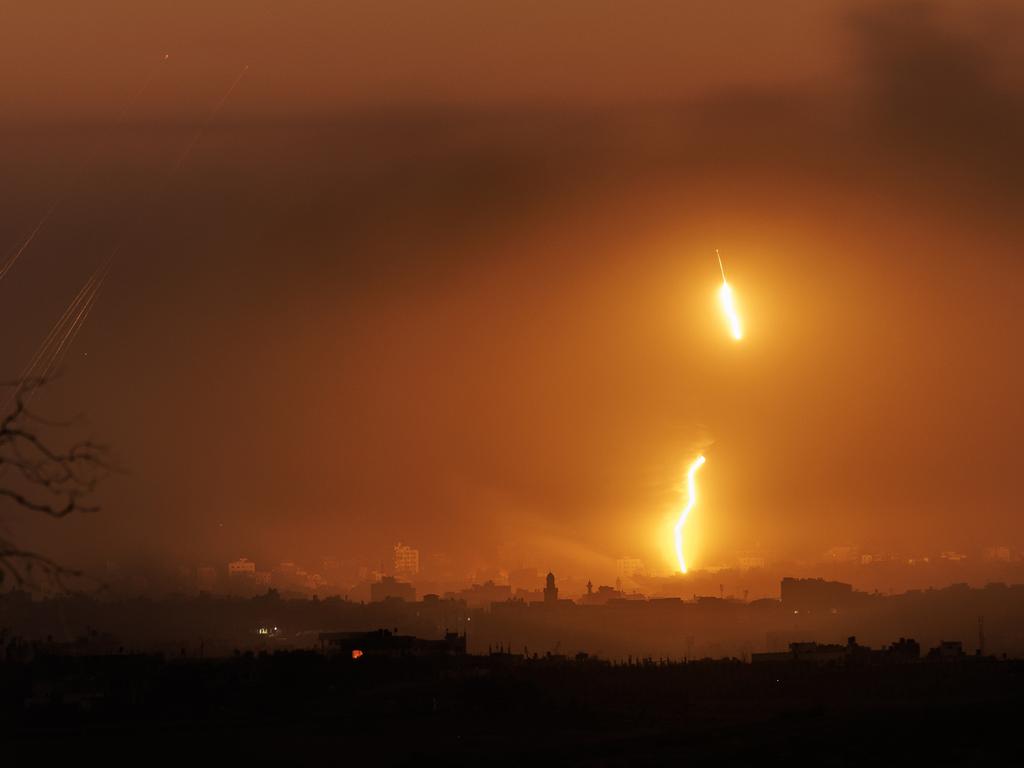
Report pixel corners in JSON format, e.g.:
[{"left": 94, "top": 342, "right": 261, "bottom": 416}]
[{"left": 6, "top": 543, "right": 1024, "bottom": 662}]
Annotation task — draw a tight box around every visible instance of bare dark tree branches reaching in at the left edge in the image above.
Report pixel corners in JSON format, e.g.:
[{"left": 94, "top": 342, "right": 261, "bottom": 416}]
[{"left": 0, "top": 379, "right": 113, "bottom": 589}]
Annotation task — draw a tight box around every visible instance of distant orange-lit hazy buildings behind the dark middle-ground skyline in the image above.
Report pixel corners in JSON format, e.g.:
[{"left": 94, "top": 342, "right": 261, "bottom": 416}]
[{"left": 101, "top": 542, "right": 1024, "bottom": 607}]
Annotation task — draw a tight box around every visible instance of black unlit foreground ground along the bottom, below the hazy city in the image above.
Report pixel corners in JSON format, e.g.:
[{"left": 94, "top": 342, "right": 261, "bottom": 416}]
[{"left": 0, "top": 652, "right": 1024, "bottom": 766}]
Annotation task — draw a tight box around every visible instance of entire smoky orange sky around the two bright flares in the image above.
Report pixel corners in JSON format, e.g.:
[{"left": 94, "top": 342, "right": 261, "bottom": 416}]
[{"left": 0, "top": 1, "right": 1024, "bottom": 581}]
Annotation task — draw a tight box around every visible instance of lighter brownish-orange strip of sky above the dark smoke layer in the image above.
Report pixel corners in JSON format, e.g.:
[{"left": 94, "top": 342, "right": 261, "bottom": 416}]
[{"left": 0, "top": 0, "right": 843, "bottom": 119}]
